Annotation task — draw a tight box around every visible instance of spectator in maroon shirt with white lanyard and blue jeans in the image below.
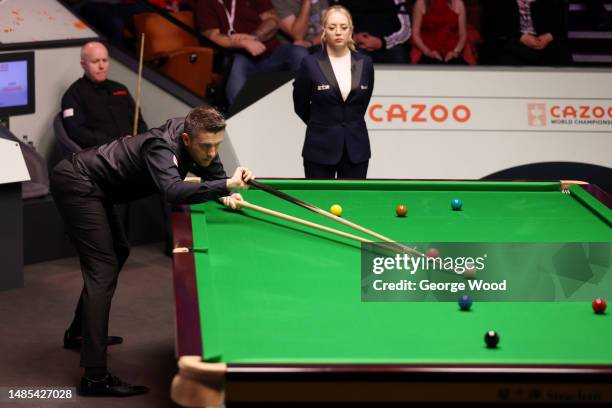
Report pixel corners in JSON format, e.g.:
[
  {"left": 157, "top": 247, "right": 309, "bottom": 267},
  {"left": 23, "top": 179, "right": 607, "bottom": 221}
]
[{"left": 195, "top": 0, "right": 308, "bottom": 105}]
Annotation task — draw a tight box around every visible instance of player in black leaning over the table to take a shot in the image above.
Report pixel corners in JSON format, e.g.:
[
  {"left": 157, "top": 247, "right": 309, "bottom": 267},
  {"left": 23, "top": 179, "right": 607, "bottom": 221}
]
[{"left": 51, "top": 107, "right": 253, "bottom": 396}]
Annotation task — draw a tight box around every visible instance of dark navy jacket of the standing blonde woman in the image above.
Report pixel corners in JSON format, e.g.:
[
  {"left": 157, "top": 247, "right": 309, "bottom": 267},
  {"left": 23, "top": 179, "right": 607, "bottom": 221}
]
[{"left": 293, "top": 49, "right": 374, "bottom": 165}]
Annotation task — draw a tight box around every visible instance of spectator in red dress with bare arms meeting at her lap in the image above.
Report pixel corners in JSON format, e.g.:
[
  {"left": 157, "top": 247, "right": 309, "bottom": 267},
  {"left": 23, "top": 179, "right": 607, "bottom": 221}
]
[{"left": 410, "top": 0, "right": 478, "bottom": 65}]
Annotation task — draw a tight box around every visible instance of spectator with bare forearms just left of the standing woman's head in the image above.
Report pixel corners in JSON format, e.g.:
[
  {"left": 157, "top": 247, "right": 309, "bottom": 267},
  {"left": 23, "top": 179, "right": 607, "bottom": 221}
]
[{"left": 272, "top": 0, "right": 328, "bottom": 50}]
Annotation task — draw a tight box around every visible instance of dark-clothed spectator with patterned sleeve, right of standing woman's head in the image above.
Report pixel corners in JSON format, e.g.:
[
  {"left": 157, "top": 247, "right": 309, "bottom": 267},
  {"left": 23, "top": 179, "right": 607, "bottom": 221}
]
[{"left": 333, "top": 0, "right": 411, "bottom": 64}]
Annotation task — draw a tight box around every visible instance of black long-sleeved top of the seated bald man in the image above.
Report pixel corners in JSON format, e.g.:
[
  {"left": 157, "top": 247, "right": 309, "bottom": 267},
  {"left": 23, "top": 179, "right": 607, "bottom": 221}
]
[{"left": 62, "top": 76, "right": 147, "bottom": 148}]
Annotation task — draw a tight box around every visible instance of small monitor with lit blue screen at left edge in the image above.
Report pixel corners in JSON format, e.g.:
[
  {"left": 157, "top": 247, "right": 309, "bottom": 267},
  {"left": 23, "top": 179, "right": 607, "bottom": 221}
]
[{"left": 0, "top": 52, "right": 35, "bottom": 117}]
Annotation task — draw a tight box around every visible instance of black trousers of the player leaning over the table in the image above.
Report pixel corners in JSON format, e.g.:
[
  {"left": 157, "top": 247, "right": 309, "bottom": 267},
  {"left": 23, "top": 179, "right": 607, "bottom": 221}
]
[{"left": 51, "top": 160, "right": 130, "bottom": 367}]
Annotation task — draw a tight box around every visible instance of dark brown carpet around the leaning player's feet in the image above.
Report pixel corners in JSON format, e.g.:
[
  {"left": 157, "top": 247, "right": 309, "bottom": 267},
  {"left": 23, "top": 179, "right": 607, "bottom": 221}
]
[{"left": 0, "top": 244, "right": 176, "bottom": 408}]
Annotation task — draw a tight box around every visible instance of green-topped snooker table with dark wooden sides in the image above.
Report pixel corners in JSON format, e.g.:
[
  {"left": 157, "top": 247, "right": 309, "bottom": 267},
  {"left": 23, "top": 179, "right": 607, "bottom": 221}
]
[{"left": 171, "top": 180, "right": 612, "bottom": 406}]
